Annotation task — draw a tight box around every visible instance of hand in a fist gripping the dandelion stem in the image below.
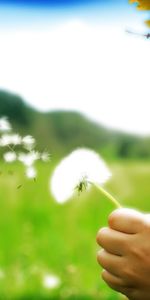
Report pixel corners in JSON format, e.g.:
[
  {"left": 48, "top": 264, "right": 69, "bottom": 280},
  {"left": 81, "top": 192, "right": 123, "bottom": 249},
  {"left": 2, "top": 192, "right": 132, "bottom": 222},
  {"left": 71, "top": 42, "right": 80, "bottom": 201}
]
[{"left": 97, "top": 208, "right": 150, "bottom": 300}]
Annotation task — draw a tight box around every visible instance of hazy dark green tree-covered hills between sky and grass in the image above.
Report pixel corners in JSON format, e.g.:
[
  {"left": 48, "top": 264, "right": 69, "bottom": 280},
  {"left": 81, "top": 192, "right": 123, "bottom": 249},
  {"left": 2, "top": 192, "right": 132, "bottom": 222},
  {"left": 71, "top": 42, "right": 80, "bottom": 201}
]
[{"left": 0, "top": 90, "right": 150, "bottom": 160}]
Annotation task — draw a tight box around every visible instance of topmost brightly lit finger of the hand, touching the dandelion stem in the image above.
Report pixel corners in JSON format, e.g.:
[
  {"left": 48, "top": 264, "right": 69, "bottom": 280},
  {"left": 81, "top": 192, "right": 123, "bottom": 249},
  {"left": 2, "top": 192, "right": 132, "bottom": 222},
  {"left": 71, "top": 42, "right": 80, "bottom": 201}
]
[{"left": 108, "top": 208, "right": 144, "bottom": 234}]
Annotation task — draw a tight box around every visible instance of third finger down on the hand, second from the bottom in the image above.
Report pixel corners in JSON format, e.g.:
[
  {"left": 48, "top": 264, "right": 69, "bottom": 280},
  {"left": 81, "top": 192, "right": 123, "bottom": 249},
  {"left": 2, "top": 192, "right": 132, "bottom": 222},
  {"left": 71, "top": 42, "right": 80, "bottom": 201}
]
[{"left": 97, "top": 249, "right": 123, "bottom": 277}]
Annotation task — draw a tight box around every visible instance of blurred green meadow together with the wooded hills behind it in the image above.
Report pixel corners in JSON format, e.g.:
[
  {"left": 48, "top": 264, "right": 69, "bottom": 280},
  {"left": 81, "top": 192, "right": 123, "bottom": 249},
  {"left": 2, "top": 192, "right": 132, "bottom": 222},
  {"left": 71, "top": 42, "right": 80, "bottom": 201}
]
[{"left": 0, "top": 91, "right": 150, "bottom": 300}]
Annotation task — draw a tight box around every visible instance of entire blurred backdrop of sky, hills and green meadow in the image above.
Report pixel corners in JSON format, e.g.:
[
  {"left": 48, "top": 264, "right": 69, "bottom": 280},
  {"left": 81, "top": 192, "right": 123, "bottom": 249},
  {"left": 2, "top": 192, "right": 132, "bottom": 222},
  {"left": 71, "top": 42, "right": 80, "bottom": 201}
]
[{"left": 0, "top": 0, "right": 150, "bottom": 300}]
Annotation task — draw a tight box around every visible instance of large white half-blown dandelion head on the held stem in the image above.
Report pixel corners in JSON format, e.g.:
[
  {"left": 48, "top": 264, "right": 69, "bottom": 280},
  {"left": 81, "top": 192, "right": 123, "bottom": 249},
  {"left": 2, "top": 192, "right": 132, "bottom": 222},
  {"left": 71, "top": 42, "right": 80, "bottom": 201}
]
[{"left": 50, "top": 148, "right": 111, "bottom": 203}]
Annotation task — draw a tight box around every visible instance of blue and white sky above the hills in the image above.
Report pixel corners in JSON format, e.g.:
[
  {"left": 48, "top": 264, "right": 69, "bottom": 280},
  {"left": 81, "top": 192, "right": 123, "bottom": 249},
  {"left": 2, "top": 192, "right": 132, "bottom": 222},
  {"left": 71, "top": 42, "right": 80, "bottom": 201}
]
[{"left": 0, "top": 0, "right": 150, "bottom": 134}]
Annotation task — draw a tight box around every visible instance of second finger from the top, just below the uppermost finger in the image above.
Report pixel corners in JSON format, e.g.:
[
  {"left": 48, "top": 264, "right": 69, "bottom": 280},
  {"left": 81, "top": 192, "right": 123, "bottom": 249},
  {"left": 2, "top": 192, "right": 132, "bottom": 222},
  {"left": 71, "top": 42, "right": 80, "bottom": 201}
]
[{"left": 97, "top": 227, "right": 130, "bottom": 255}]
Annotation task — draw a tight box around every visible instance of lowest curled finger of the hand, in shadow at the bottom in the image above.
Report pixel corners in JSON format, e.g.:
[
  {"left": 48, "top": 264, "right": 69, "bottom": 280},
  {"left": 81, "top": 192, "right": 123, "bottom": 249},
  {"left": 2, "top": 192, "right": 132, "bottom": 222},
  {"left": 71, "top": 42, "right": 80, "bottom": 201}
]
[{"left": 102, "top": 270, "right": 133, "bottom": 296}]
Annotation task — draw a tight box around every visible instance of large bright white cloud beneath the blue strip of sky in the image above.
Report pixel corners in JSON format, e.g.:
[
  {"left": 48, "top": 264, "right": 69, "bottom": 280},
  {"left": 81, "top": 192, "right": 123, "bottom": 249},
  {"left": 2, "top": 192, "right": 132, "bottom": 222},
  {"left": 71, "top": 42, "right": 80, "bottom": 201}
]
[{"left": 0, "top": 19, "right": 150, "bottom": 133}]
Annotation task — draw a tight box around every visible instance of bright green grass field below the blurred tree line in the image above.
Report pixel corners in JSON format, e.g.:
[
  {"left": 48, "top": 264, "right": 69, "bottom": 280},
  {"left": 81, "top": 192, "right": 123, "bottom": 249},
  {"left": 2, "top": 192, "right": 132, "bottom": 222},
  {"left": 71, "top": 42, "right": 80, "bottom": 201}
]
[{"left": 0, "top": 161, "right": 150, "bottom": 300}]
